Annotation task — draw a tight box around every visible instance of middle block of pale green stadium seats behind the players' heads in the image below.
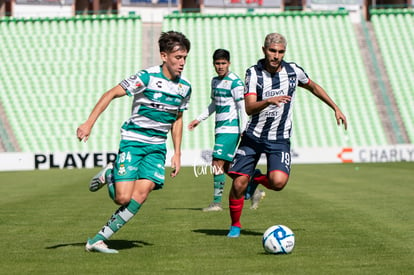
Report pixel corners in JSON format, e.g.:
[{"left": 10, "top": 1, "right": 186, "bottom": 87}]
[{"left": 163, "top": 12, "right": 387, "bottom": 151}]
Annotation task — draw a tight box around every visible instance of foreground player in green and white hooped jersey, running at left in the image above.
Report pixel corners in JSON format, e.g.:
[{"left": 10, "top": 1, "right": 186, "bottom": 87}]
[{"left": 77, "top": 31, "right": 191, "bottom": 253}]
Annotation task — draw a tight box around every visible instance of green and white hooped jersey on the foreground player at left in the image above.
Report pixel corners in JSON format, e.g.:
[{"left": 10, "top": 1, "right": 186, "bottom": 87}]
[{"left": 120, "top": 66, "right": 191, "bottom": 144}]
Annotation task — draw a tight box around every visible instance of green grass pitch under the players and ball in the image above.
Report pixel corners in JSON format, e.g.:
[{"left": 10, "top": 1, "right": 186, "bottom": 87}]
[{"left": 0, "top": 163, "right": 414, "bottom": 275}]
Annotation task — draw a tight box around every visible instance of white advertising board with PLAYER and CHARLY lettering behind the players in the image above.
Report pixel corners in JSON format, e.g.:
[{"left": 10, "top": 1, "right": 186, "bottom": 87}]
[{"left": 0, "top": 144, "right": 414, "bottom": 171}]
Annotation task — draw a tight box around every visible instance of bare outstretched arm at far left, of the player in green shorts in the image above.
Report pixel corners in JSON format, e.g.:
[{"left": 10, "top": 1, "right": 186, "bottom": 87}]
[{"left": 76, "top": 85, "right": 126, "bottom": 142}]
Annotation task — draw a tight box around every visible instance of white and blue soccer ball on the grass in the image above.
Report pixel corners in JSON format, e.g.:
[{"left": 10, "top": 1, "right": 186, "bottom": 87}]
[{"left": 262, "top": 224, "right": 295, "bottom": 254}]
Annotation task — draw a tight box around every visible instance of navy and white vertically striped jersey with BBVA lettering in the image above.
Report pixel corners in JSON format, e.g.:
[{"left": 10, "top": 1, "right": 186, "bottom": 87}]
[{"left": 244, "top": 59, "right": 310, "bottom": 140}]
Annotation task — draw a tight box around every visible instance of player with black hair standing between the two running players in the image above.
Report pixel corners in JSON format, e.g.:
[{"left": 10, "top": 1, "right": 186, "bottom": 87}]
[{"left": 188, "top": 49, "right": 265, "bottom": 211}]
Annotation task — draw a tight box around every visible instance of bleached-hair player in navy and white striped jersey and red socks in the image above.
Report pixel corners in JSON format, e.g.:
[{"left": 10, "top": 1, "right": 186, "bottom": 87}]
[{"left": 227, "top": 33, "right": 347, "bottom": 238}]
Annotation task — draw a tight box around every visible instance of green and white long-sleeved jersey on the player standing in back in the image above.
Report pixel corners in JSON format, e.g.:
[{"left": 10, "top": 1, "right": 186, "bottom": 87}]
[{"left": 197, "top": 72, "right": 247, "bottom": 134}]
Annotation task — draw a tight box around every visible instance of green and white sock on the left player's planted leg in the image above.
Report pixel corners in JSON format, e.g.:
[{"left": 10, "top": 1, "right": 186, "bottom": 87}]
[{"left": 92, "top": 199, "right": 141, "bottom": 243}]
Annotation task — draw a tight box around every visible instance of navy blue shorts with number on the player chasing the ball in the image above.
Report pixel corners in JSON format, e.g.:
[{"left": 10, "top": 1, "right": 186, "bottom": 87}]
[{"left": 229, "top": 133, "right": 291, "bottom": 179}]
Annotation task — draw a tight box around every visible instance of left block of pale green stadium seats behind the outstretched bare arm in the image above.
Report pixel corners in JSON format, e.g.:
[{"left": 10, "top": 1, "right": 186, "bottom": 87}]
[{"left": 0, "top": 16, "right": 142, "bottom": 152}]
